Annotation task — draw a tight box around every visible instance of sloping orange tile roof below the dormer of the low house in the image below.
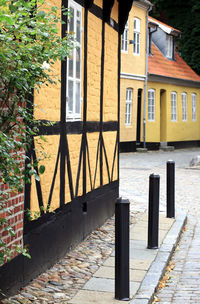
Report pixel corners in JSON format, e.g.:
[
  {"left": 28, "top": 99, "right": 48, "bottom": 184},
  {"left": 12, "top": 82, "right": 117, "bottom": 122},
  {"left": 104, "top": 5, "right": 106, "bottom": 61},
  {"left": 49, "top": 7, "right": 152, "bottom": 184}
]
[{"left": 148, "top": 43, "right": 200, "bottom": 82}]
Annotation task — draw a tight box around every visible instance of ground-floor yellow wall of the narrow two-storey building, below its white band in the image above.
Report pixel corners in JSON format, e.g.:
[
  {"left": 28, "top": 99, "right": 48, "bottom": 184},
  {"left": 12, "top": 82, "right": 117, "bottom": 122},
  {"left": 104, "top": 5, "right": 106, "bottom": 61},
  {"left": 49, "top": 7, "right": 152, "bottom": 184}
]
[{"left": 120, "top": 78, "right": 144, "bottom": 142}]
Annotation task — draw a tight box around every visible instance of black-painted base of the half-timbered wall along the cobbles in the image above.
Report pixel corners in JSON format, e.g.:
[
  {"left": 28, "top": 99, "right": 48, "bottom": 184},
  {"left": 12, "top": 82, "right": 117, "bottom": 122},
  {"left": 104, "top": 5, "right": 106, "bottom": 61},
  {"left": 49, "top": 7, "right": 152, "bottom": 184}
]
[{"left": 0, "top": 181, "right": 119, "bottom": 296}]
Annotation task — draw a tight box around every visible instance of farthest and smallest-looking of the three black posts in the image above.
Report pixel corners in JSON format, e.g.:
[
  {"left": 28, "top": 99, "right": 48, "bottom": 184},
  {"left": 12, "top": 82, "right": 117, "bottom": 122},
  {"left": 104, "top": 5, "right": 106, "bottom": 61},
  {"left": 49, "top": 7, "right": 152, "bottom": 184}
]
[{"left": 167, "top": 160, "right": 175, "bottom": 218}]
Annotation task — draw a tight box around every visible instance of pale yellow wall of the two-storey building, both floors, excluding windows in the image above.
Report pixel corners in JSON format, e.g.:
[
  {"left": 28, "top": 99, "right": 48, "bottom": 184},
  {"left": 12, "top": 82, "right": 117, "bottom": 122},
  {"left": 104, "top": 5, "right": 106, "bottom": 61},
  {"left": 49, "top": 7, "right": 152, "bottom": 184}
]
[{"left": 120, "top": 2, "right": 146, "bottom": 142}]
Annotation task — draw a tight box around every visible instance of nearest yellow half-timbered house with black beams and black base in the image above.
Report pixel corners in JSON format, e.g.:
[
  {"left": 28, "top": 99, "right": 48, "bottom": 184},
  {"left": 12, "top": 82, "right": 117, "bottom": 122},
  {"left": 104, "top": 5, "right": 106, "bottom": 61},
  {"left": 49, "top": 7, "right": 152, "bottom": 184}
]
[{"left": 0, "top": 0, "right": 132, "bottom": 294}]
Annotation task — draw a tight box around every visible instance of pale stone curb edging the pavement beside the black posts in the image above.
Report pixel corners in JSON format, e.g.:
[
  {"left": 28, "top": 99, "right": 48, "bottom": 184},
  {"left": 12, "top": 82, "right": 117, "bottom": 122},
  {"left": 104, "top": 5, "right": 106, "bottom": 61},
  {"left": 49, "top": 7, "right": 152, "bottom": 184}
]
[{"left": 130, "top": 211, "right": 187, "bottom": 304}]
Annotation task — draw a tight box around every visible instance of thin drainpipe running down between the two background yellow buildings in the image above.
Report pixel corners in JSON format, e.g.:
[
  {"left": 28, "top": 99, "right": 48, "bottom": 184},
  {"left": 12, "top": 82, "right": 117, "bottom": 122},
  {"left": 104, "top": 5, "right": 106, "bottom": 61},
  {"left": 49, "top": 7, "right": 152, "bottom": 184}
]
[{"left": 143, "top": 6, "right": 152, "bottom": 149}]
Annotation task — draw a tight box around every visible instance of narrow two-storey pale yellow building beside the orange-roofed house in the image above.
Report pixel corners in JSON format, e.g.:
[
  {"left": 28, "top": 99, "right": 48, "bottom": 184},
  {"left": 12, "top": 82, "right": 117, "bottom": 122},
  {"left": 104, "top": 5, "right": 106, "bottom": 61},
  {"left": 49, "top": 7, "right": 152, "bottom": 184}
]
[{"left": 120, "top": 0, "right": 152, "bottom": 152}]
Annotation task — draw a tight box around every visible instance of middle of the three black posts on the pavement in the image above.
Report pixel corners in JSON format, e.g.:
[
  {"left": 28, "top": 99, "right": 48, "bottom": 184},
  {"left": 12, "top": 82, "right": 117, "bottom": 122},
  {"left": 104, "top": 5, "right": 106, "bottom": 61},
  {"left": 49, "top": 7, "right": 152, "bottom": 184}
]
[{"left": 147, "top": 174, "right": 160, "bottom": 249}]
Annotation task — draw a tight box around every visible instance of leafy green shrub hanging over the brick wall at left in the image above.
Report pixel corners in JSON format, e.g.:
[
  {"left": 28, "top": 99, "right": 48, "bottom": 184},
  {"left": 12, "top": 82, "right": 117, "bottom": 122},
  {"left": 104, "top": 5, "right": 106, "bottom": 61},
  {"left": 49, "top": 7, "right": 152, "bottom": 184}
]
[{"left": 0, "top": 0, "right": 74, "bottom": 264}]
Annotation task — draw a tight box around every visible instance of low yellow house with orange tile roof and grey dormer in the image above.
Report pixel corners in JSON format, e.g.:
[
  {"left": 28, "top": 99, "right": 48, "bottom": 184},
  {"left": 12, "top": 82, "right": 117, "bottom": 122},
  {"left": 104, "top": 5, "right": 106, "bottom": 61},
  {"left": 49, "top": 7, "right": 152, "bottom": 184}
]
[{"left": 145, "top": 18, "right": 200, "bottom": 148}]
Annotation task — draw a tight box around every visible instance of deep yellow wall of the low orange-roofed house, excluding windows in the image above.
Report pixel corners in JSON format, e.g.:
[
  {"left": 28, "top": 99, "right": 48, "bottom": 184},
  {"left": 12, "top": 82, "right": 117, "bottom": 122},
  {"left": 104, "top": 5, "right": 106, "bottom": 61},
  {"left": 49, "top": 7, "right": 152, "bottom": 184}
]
[{"left": 146, "top": 82, "right": 200, "bottom": 142}]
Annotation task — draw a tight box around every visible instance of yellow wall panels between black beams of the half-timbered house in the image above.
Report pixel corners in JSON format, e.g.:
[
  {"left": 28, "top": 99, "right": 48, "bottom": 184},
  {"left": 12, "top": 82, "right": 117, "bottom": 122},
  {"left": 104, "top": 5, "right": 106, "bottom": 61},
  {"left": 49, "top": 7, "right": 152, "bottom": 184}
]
[{"left": 31, "top": 0, "right": 118, "bottom": 212}]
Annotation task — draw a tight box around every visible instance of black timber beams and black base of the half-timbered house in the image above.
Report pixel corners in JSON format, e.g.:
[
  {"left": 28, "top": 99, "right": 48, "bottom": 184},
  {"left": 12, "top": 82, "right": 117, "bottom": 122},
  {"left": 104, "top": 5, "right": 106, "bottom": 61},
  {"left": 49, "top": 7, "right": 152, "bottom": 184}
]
[{"left": 0, "top": 0, "right": 135, "bottom": 295}]
